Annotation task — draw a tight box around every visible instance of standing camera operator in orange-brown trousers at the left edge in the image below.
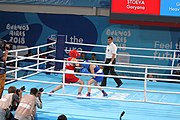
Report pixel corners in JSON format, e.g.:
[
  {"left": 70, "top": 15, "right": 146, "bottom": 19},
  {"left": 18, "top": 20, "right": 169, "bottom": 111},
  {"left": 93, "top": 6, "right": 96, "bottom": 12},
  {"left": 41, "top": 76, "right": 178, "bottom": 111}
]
[{"left": 0, "top": 44, "right": 10, "bottom": 98}]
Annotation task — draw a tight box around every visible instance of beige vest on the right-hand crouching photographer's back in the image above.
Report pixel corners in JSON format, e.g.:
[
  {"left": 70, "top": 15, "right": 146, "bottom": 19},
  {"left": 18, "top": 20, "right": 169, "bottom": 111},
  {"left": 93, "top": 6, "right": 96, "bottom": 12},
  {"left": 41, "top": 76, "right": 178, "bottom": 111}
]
[{"left": 15, "top": 95, "right": 36, "bottom": 118}]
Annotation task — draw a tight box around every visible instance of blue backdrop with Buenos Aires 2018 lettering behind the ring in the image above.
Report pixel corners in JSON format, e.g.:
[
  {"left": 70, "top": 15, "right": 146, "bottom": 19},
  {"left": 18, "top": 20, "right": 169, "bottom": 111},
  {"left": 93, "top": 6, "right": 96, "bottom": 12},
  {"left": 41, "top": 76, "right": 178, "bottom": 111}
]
[{"left": 0, "top": 12, "right": 180, "bottom": 69}]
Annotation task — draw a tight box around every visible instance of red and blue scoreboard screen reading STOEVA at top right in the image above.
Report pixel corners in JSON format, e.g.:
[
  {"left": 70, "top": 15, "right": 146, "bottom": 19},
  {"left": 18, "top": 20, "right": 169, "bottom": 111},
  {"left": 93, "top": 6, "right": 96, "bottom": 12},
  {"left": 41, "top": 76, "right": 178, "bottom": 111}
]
[{"left": 110, "top": 0, "right": 180, "bottom": 27}]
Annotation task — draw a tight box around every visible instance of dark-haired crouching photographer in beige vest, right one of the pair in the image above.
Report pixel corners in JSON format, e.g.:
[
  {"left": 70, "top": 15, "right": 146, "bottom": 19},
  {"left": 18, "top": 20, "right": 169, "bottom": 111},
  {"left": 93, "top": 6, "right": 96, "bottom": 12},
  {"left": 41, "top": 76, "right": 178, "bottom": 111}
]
[{"left": 15, "top": 88, "right": 44, "bottom": 120}]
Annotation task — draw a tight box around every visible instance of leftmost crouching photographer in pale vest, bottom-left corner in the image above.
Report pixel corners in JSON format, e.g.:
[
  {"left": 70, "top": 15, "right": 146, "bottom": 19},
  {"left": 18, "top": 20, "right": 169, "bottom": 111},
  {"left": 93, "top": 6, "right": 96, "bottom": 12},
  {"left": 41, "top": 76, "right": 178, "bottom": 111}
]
[{"left": 0, "top": 86, "right": 22, "bottom": 120}]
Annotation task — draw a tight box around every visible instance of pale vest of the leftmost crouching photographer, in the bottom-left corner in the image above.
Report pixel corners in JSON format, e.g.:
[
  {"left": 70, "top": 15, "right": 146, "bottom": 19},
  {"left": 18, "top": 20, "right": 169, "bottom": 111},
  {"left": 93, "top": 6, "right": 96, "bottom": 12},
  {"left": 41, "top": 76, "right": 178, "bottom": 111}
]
[{"left": 0, "top": 93, "right": 14, "bottom": 109}]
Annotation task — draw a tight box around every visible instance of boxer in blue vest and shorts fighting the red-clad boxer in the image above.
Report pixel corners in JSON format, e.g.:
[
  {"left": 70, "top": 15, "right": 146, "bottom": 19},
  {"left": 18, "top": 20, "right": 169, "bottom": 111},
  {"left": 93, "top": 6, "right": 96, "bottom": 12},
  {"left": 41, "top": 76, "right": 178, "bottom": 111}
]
[{"left": 81, "top": 61, "right": 108, "bottom": 96}]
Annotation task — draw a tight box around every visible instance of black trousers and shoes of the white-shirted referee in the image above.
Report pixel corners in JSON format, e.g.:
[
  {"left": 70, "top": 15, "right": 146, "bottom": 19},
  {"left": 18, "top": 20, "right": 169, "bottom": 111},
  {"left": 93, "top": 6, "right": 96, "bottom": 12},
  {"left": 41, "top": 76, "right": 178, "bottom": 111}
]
[{"left": 100, "top": 58, "right": 123, "bottom": 87}]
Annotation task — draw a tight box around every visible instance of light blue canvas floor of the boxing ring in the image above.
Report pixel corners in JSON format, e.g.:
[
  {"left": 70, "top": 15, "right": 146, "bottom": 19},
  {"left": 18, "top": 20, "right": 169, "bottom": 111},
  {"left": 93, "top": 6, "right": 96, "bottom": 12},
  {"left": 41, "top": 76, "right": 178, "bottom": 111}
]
[{"left": 5, "top": 73, "right": 180, "bottom": 120}]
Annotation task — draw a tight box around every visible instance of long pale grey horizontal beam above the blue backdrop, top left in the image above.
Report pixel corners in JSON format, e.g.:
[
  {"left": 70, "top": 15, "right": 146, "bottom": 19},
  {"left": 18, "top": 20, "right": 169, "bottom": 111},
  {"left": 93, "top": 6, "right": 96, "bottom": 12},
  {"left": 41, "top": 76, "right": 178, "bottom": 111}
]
[{"left": 0, "top": 4, "right": 110, "bottom": 16}]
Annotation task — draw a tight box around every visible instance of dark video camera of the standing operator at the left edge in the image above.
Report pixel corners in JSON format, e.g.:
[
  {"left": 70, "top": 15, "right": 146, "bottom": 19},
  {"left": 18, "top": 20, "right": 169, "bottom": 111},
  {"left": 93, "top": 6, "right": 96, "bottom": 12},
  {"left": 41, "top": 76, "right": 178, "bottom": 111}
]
[{"left": 0, "top": 39, "right": 13, "bottom": 51}]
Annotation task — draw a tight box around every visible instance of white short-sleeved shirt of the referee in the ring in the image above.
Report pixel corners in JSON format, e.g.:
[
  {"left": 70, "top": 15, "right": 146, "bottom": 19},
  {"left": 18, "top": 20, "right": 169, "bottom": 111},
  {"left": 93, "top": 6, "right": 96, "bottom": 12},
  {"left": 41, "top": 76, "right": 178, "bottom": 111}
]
[{"left": 106, "top": 42, "right": 117, "bottom": 59}]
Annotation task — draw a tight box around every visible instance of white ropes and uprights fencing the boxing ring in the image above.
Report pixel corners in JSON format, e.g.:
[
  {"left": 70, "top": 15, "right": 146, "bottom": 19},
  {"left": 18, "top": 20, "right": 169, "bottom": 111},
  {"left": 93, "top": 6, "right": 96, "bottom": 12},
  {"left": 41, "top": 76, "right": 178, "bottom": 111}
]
[{"left": 6, "top": 42, "right": 180, "bottom": 105}]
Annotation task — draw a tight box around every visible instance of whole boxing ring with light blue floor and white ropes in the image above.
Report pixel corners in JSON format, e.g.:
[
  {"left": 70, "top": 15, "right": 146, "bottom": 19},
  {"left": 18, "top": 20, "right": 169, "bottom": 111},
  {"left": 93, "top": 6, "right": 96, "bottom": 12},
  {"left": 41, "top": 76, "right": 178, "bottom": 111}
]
[{"left": 4, "top": 42, "right": 180, "bottom": 120}]
